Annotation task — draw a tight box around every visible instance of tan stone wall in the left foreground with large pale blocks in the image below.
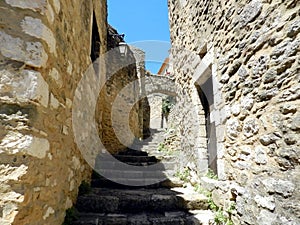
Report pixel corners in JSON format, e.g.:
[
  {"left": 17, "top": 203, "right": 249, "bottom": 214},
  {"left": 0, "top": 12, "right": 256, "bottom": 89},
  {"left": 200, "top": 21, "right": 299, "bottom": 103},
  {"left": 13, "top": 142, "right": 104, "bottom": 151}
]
[{"left": 0, "top": 0, "right": 107, "bottom": 225}]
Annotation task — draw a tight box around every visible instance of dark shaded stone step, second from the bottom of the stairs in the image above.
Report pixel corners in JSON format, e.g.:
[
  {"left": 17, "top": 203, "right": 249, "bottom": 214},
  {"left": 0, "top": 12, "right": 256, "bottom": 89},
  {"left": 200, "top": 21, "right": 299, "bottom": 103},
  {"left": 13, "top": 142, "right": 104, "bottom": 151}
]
[{"left": 76, "top": 188, "right": 188, "bottom": 213}]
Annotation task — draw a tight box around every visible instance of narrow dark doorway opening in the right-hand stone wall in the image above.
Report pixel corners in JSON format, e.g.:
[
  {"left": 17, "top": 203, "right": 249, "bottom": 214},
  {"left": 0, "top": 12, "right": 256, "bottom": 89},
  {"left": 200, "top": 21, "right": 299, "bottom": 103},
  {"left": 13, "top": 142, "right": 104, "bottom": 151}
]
[{"left": 196, "top": 77, "right": 218, "bottom": 174}]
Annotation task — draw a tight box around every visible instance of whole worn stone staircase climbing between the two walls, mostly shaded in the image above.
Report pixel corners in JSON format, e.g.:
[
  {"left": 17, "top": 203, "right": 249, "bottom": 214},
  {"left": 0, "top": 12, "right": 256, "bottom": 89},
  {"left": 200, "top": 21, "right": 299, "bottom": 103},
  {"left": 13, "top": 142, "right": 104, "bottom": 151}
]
[{"left": 73, "top": 129, "right": 213, "bottom": 225}]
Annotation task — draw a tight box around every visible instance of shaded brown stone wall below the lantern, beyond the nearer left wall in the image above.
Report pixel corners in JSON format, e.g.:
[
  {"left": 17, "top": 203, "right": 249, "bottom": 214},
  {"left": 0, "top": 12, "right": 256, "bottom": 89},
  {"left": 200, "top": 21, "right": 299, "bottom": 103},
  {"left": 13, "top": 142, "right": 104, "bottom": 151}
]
[{"left": 98, "top": 27, "right": 144, "bottom": 153}]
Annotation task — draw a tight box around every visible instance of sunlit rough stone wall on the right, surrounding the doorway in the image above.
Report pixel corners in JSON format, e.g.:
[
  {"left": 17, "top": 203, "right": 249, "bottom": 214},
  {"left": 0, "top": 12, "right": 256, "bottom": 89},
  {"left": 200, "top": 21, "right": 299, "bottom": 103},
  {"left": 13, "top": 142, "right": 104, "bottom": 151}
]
[{"left": 169, "top": 0, "right": 300, "bottom": 224}]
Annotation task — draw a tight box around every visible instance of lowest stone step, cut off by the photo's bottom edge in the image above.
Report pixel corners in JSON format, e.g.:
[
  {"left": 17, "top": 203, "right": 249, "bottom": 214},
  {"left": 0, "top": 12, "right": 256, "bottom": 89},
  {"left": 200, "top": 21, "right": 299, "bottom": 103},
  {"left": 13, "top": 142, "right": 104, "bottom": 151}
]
[{"left": 73, "top": 211, "right": 203, "bottom": 225}]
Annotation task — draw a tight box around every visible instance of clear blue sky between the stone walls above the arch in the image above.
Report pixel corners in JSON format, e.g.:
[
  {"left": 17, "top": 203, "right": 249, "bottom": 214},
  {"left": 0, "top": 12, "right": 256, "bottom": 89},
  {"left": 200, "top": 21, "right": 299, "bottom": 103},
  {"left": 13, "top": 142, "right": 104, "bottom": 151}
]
[{"left": 108, "top": 0, "right": 170, "bottom": 73}]
